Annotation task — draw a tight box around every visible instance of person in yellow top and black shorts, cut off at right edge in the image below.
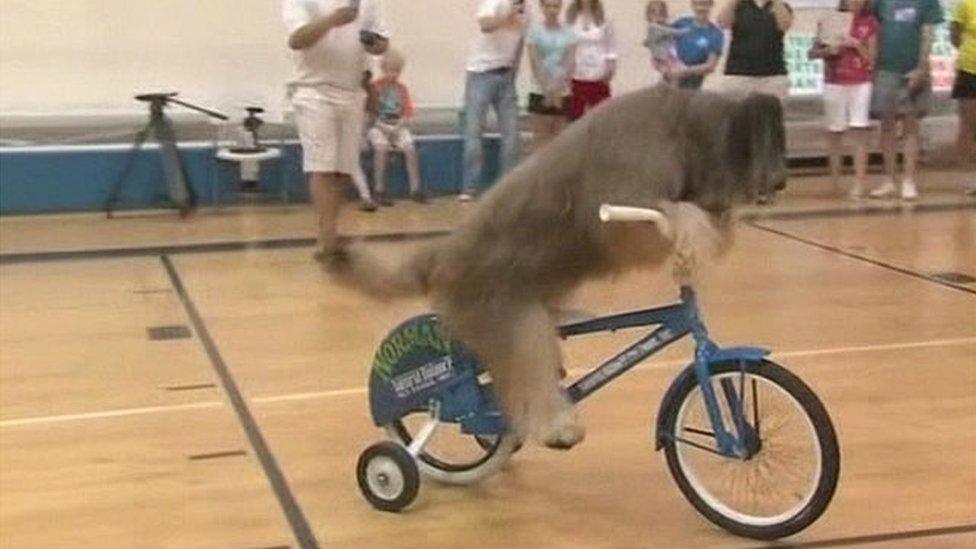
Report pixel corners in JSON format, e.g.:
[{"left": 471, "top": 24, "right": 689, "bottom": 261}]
[{"left": 949, "top": 0, "right": 976, "bottom": 194}]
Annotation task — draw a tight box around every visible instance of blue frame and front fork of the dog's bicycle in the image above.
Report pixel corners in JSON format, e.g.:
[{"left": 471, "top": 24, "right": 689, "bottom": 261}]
[{"left": 559, "top": 286, "right": 768, "bottom": 459}]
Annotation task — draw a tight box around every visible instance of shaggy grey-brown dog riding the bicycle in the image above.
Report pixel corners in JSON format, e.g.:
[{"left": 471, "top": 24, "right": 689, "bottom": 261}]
[{"left": 322, "top": 82, "right": 786, "bottom": 448}]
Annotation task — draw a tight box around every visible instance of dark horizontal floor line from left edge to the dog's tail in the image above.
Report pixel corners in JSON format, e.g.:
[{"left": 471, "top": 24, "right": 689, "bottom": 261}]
[{"left": 0, "top": 230, "right": 450, "bottom": 265}]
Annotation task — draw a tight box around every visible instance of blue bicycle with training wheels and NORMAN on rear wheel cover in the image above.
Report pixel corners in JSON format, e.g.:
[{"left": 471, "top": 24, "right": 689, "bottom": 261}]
[{"left": 357, "top": 209, "right": 840, "bottom": 539}]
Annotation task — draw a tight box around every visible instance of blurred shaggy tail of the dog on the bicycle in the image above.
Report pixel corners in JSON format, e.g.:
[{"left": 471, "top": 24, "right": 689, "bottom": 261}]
[{"left": 317, "top": 241, "right": 439, "bottom": 299}]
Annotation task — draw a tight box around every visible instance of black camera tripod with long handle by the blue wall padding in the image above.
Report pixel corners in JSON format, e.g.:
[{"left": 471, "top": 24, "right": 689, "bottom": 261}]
[{"left": 105, "top": 92, "right": 228, "bottom": 218}]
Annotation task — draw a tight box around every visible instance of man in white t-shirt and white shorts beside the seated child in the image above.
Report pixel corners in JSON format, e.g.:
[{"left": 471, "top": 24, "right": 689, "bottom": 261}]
[{"left": 282, "top": 0, "right": 388, "bottom": 253}]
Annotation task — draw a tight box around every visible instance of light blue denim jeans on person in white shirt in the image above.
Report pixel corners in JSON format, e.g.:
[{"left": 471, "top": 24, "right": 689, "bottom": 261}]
[{"left": 461, "top": 70, "right": 519, "bottom": 195}]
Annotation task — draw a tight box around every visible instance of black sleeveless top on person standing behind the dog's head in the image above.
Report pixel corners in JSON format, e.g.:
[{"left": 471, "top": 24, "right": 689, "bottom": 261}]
[{"left": 725, "top": 0, "right": 793, "bottom": 76}]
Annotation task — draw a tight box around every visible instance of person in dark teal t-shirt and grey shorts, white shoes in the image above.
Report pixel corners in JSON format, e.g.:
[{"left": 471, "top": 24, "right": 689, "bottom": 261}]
[{"left": 870, "top": 0, "right": 942, "bottom": 200}]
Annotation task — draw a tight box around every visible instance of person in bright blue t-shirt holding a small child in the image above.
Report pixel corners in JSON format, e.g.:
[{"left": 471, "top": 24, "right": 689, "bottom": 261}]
[{"left": 671, "top": 0, "right": 725, "bottom": 90}]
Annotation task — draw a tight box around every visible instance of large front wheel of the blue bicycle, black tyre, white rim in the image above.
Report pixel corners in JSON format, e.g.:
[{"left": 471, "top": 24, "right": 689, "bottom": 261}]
[{"left": 662, "top": 361, "right": 840, "bottom": 539}]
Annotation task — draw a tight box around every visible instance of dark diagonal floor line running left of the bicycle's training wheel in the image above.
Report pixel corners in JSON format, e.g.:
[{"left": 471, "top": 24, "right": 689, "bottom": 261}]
[{"left": 160, "top": 255, "right": 319, "bottom": 549}]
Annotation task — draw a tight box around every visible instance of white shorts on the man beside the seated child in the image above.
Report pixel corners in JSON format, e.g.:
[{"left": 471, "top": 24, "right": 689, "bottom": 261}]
[{"left": 291, "top": 88, "right": 365, "bottom": 174}]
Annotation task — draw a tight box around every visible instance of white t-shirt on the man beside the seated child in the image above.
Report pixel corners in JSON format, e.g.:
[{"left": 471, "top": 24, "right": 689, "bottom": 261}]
[{"left": 281, "top": 0, "right": 389, "bottom": 93}]
